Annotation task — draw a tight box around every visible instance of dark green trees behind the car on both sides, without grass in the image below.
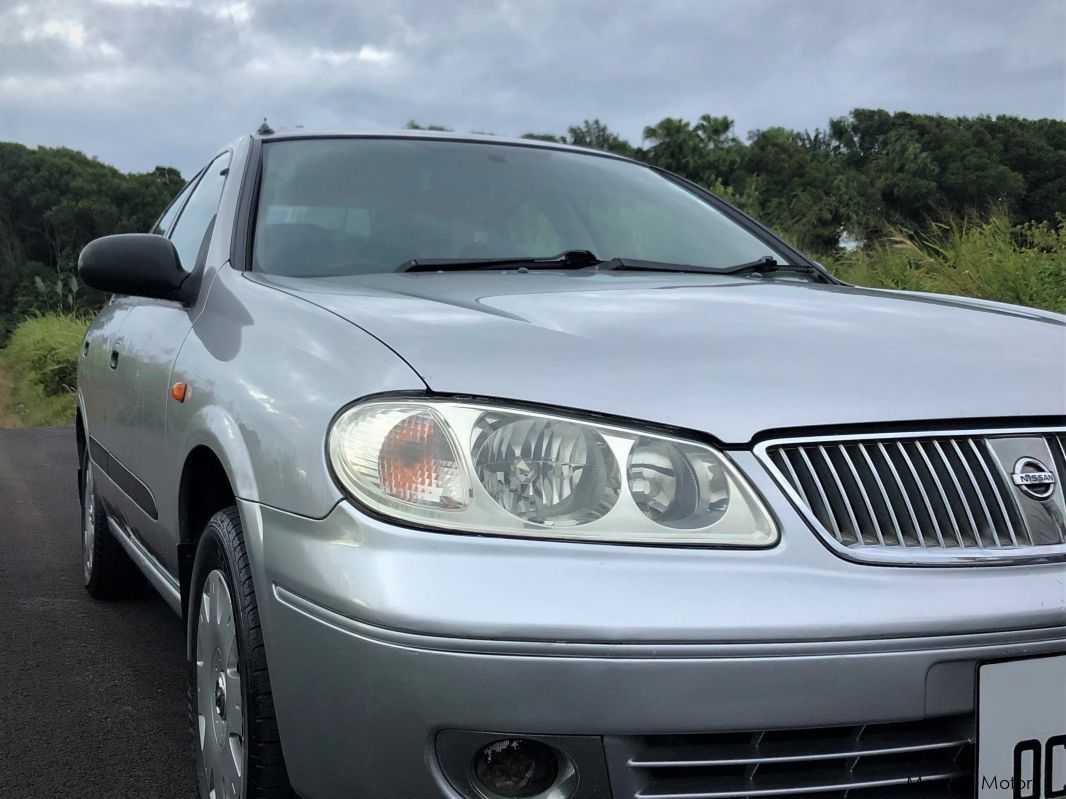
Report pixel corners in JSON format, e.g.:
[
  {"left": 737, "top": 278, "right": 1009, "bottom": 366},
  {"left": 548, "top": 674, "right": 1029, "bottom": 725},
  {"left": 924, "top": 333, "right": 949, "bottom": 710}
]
[{"left": 0, "top": 109, "right": 1066, "bottom": 344}]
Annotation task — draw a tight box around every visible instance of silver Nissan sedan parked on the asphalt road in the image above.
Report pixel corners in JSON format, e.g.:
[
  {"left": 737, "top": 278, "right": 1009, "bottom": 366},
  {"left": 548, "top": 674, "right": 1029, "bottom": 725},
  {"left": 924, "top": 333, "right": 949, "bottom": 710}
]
[{"left": 77, "top": 131, "right": 1066, "bottom": 799}]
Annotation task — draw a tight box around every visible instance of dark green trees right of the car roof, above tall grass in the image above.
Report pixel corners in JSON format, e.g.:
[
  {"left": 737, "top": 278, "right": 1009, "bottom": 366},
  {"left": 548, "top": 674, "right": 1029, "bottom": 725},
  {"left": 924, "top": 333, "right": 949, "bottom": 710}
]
[{"left": 513, "top": 109, "right": 1066, "bottom": 254}]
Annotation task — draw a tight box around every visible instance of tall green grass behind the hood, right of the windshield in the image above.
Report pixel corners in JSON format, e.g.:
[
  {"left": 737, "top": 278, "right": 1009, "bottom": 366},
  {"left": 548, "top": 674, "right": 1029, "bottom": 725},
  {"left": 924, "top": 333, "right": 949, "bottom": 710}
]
[{"left": 824, "top": 214, "right": 1066, "bottom": 313}]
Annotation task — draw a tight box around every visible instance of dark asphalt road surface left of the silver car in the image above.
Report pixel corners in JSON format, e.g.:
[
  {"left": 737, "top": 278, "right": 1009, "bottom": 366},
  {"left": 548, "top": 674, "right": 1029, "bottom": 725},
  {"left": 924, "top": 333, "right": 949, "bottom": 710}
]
[{"left": 0, "top": 428, "right": 195, "bottom": 799}]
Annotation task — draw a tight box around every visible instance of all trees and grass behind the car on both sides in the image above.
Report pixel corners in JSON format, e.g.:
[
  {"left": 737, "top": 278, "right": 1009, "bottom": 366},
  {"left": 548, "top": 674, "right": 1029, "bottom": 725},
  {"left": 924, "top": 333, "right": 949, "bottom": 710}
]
[{"left": 0, "top": 109, "right": 1066, "bottom": 426}]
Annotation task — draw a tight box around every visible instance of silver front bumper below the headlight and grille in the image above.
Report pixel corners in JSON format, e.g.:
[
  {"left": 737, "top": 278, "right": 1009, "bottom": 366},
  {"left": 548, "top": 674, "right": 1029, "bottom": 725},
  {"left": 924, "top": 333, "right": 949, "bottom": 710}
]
[{"left": 241, "top": 475, "right": 1066, "bottom": 799}]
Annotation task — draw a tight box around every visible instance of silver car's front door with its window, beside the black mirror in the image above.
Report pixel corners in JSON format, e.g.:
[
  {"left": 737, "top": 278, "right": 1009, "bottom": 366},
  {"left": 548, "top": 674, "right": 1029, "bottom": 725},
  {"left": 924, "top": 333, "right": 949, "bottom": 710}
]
[{"left": 103, "top": 151, "right": 230, "bottom": 575}]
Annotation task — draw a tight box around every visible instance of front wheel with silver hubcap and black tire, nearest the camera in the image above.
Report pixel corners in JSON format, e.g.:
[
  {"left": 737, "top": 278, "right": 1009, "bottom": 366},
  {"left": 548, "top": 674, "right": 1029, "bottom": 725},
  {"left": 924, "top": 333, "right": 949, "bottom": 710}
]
[{"left": 189, "top": 507, "right": 295, "bottom": 799}]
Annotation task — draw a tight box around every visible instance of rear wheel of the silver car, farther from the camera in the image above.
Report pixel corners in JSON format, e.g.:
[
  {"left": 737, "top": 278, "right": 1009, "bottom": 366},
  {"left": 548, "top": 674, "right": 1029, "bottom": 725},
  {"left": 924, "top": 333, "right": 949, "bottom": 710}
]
[{"left": 81, "top": 452, "right": 144, "bottom": 599}]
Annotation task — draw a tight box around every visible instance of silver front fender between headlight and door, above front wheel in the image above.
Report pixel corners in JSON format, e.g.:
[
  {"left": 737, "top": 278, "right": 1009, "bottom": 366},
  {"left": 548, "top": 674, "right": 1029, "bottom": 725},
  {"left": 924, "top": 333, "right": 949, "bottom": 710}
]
[{"left": 166, "top": 267, "right": 425, "bottom": 519}]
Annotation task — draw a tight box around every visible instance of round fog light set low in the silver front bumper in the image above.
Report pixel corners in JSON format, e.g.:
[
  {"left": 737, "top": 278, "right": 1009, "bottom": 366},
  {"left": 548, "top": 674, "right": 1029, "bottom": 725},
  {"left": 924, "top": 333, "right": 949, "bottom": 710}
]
[{"left": 473, "top": 738, "right": 559, "bottom": 799}]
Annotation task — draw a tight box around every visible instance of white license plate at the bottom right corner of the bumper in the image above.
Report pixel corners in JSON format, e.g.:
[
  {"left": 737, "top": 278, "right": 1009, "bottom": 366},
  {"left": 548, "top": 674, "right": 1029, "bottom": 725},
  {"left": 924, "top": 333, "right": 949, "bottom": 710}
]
[{"left": 978, "top": 655, "right": 1066, "bottom": 799}]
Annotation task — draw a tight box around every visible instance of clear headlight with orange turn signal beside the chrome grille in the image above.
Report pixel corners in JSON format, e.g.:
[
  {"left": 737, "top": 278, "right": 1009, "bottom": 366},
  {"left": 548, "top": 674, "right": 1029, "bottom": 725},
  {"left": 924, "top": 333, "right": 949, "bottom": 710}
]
[{"left": 328, "top": 400, "right": 777, "bottom": 547}]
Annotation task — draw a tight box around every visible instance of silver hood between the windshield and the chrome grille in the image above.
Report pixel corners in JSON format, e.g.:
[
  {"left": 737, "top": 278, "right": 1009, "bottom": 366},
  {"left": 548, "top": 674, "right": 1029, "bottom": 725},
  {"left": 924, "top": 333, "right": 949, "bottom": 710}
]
[{"left": 249, "top": 271, "right": 1066, "bottom": 444}]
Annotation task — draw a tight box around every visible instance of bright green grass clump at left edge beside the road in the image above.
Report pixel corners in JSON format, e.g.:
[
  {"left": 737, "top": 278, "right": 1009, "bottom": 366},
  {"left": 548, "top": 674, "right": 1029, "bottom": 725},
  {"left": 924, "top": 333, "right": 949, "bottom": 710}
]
[{"left": 0, "top": 314, "right": 88, "bottom": 426}]
